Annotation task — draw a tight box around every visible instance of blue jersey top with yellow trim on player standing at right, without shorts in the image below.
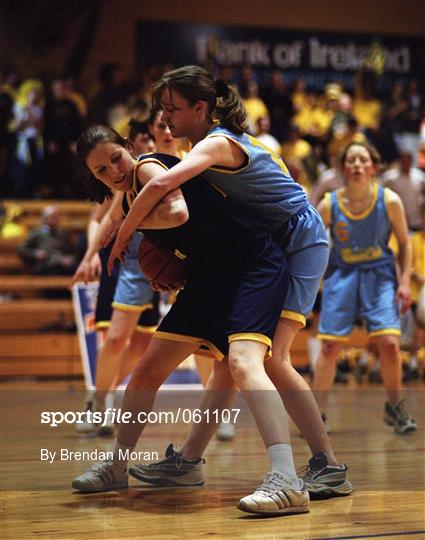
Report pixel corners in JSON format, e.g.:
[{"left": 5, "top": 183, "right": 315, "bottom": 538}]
[{"left": 326, "top": 184, "right": 394, "bottom": 268}]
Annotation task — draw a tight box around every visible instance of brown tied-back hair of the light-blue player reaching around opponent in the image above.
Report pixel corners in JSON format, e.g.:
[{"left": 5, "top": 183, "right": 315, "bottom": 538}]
[{"left": 152, "top": 66, "right": 248, "bottom": 135}]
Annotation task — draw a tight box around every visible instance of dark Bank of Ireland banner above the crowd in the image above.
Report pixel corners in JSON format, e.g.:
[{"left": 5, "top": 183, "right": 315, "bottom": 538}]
[{"left": 136, "top": 21, "right": 425, "bottom": 91}]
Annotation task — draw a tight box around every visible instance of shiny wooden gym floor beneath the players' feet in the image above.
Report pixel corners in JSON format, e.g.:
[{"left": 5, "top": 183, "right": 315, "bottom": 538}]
[{"left": 0, "top": 381, "right": 425, "bottom": 540}]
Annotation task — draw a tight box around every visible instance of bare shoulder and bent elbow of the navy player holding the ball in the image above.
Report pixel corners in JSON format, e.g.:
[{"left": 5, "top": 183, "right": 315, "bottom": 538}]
[{"left": 133, "top": 161, "right": 189, "bottom": 229}]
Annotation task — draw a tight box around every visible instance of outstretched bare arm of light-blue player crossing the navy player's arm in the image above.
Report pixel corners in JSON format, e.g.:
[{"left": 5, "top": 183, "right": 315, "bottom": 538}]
[{"left": 119, "top": 137, "right": 235, "bottom": 240}]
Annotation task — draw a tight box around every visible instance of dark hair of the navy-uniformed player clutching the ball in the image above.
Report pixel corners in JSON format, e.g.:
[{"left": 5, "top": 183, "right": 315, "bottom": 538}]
[{"left": 77, "top": 125, "right": 128, "bottom": 203}]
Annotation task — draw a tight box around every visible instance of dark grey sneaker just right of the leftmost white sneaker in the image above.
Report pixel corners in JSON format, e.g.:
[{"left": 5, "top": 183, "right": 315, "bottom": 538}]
[{"left": 128, "top": 444, "right": 205, "bottom": 487}]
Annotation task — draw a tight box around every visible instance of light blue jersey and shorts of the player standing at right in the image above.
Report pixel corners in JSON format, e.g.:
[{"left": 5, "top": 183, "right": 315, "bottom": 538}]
[{"left": 318, "top": 185, "right": 400, "bottom": 341}]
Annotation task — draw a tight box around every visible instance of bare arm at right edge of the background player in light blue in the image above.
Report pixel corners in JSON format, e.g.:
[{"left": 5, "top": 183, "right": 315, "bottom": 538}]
[{"left": 386, "top": 190, "right": 412, "bottom": 313}]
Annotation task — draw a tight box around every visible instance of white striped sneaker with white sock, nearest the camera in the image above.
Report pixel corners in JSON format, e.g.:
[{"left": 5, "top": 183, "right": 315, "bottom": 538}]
[{"left": 238, "top": 472, "right": 310, "bottom": 516}]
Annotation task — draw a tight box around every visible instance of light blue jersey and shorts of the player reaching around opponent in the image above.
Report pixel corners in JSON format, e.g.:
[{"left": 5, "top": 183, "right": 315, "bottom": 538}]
[{"left": 202, "top": 125, "right": 329, "bottom": 325}]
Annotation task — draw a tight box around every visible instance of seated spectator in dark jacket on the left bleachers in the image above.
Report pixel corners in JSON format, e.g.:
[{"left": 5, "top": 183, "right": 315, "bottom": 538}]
[{"left": 18, "top": 206, "right": 78, "bottom": 275}]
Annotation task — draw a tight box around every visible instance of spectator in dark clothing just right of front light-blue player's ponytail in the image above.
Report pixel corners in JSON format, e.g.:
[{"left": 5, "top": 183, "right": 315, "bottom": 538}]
[{"left": 261, "top": 70, "right": 294, "bottom": 141}]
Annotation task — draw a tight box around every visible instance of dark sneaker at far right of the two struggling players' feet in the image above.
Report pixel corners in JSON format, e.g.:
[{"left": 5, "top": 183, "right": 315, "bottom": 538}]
[{"left": 300, "top": 453, "right": 353, "bottom": 499}]
